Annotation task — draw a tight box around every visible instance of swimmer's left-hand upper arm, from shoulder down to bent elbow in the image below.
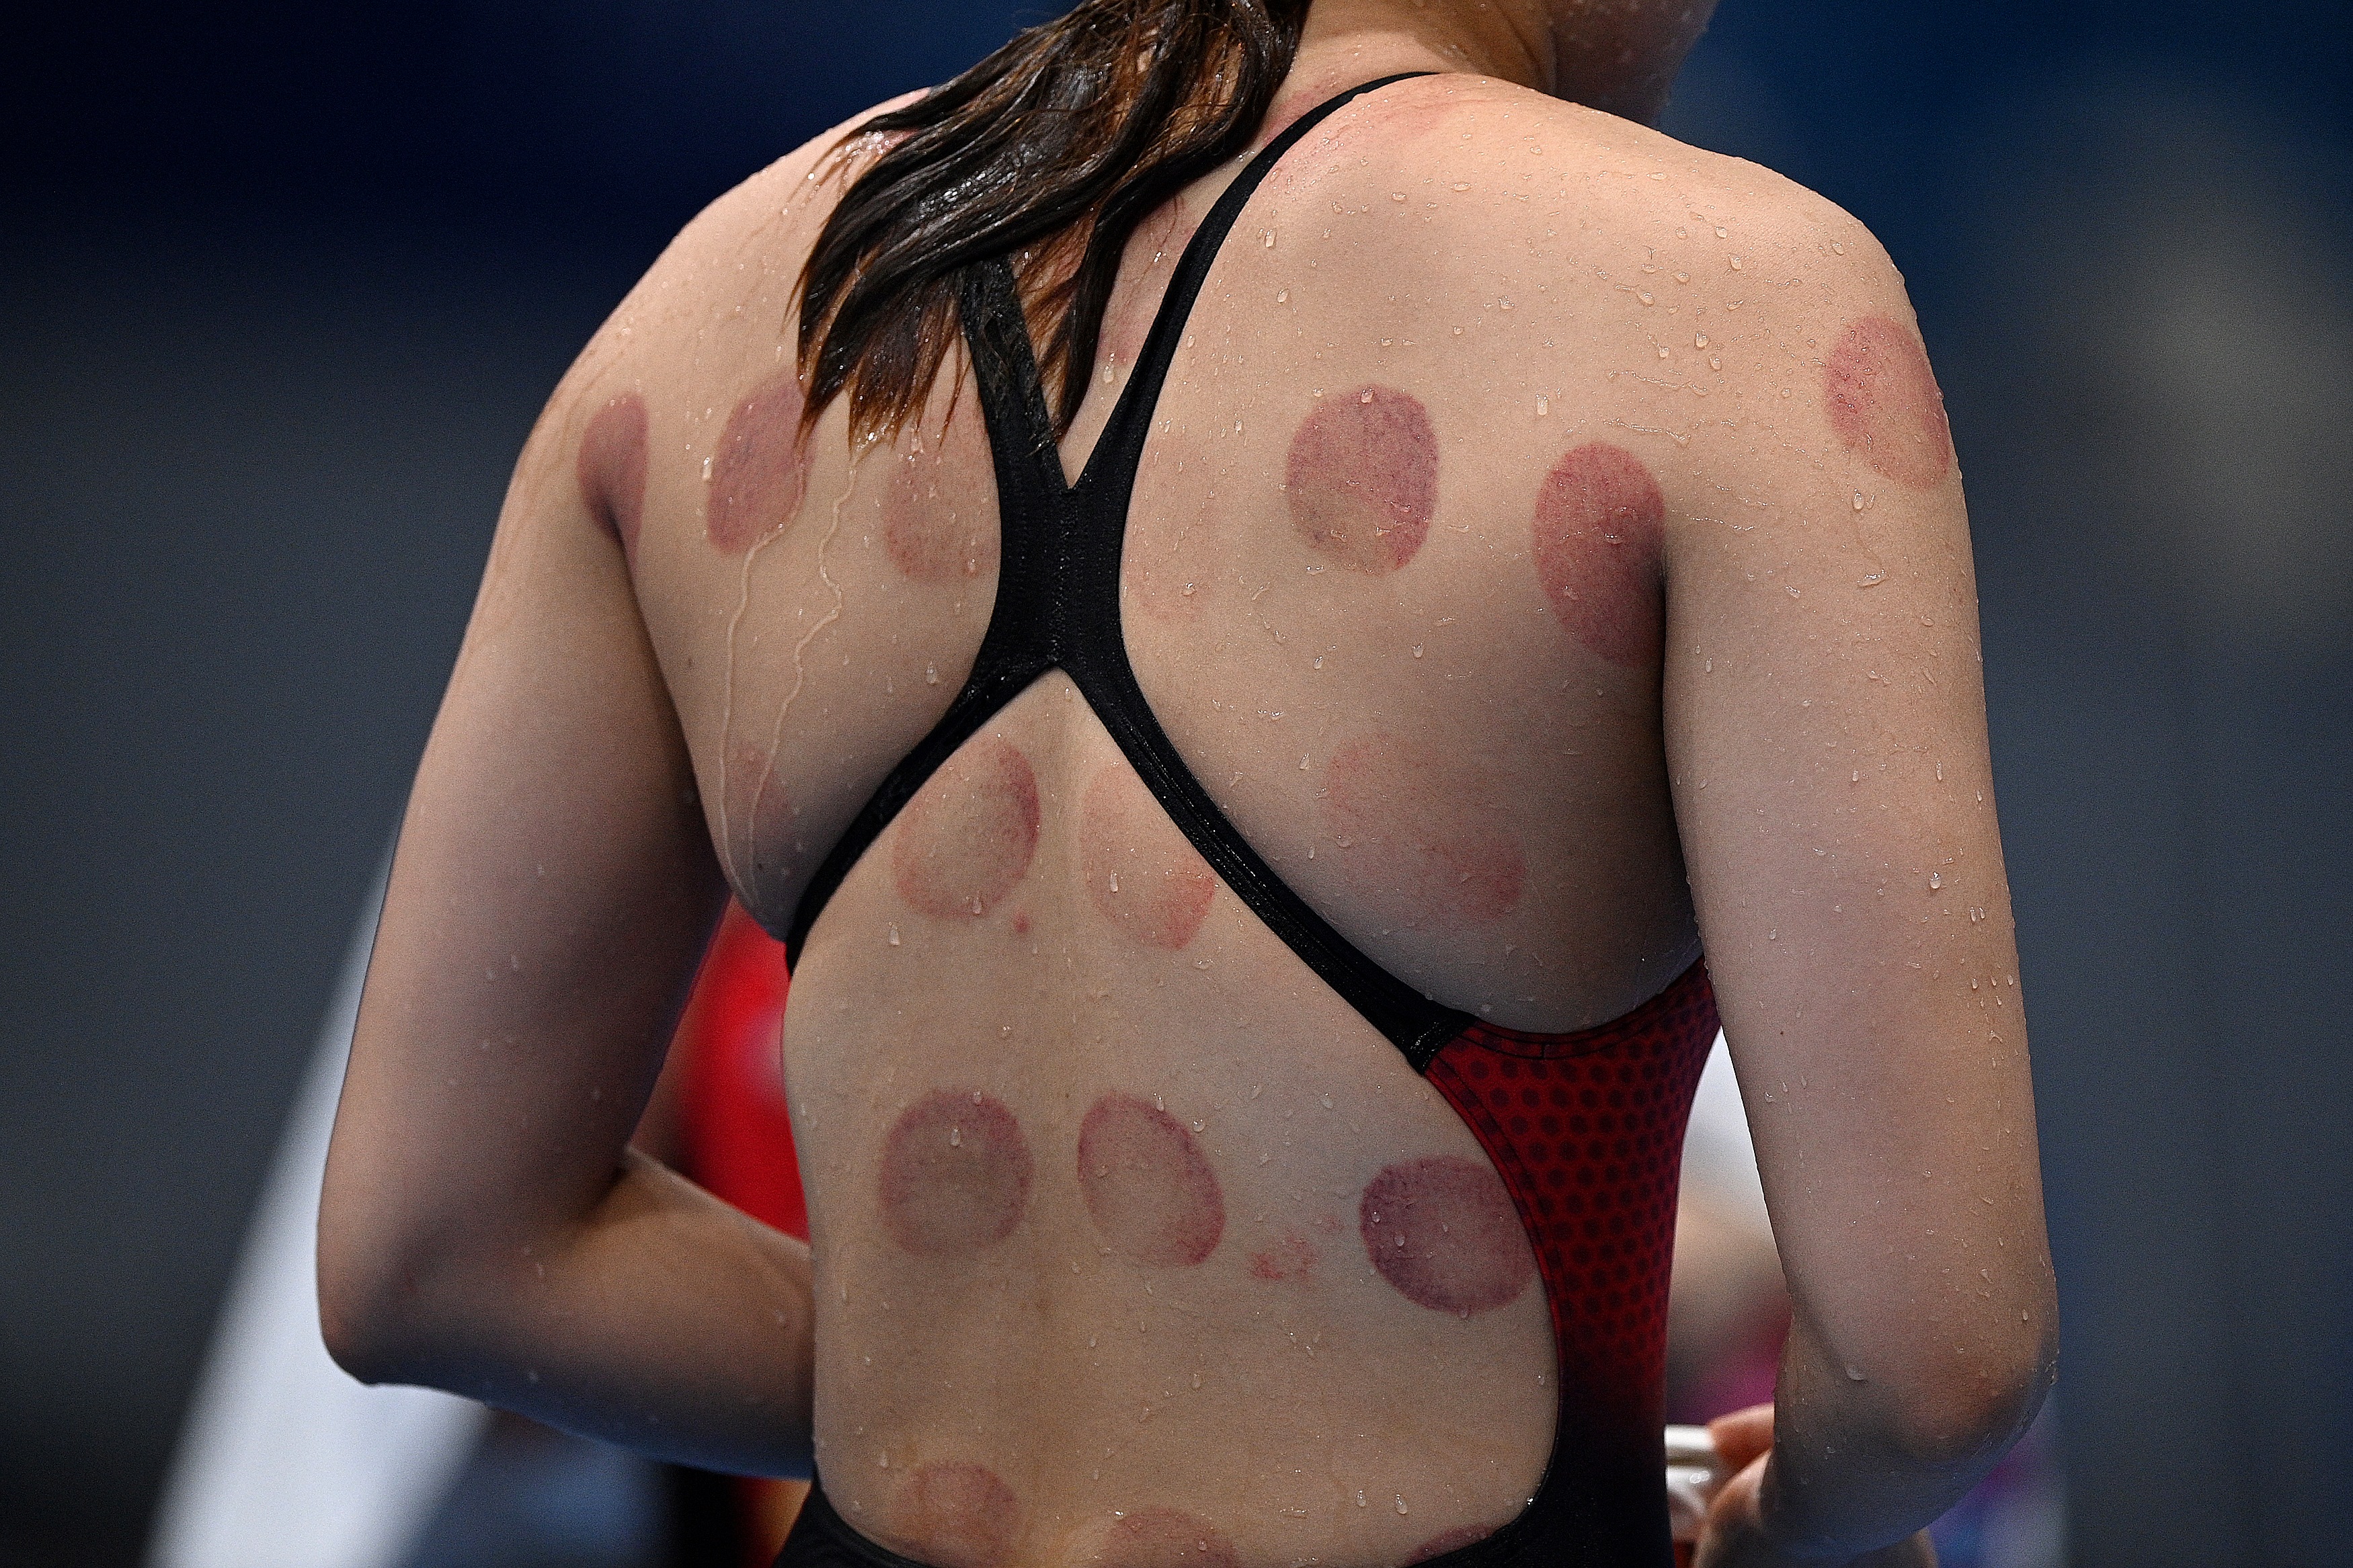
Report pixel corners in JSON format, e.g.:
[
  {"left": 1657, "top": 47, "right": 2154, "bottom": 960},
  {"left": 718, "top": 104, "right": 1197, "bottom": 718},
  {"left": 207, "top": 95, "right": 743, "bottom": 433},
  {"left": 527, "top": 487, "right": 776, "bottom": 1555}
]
[{"left": 320, "top": 329, "right": 723, "bottom": 1378}]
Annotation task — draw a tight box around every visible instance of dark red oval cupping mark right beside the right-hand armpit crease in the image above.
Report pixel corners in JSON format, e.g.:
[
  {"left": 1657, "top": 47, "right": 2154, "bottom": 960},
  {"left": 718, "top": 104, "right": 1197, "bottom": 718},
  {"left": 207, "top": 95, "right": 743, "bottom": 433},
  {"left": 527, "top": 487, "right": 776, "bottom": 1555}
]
[{"left": 1534, "top": 442, "right": 1666, "bottom": 670}]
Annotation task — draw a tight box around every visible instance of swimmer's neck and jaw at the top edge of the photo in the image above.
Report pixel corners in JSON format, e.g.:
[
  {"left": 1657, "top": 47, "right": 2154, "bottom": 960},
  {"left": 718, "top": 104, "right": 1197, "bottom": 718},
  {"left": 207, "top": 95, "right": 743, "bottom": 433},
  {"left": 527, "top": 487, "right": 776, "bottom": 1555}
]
[{"left": 1297, "top": 0, "right": 1716, "bottom": 124}]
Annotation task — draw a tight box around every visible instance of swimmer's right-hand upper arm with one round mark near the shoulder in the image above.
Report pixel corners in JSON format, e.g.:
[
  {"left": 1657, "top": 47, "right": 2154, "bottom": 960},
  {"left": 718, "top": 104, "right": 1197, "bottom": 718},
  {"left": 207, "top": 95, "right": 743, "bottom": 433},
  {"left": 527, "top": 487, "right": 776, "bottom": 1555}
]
[{"left": 1666, "top": 188, "right": 2055, "bottom": 1462}]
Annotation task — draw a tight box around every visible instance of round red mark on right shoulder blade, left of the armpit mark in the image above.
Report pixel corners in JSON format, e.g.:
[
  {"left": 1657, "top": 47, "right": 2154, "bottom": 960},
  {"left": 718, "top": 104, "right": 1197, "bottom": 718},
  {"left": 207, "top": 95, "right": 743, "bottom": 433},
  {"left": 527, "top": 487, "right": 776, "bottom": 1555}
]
[{"left": 1283, "top": 386, "right": 1438, "bottom": 576}]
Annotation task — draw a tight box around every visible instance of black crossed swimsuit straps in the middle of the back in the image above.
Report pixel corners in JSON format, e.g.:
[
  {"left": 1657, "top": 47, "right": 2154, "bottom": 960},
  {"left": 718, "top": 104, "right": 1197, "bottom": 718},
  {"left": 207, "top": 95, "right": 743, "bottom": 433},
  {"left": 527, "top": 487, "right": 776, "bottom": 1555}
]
[{"left": 786, "top": 71, "right": 1471, "bottom": 1069}]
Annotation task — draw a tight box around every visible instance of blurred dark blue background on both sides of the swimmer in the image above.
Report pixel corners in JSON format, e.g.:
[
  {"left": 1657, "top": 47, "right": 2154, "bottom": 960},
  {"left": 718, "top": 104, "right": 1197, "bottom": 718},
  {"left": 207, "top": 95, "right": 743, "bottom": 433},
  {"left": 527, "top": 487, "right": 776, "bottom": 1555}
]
[{"left": 0, "top": 0, "right": 2353, "bottom": 1568}]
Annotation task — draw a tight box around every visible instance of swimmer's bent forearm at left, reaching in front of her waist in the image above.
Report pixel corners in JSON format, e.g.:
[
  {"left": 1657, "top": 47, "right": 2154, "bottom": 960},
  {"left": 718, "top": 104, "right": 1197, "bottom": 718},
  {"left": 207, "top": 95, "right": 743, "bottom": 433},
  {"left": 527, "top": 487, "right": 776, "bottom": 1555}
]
[{"left": 323, "top": 1152, "right": 812, "bottom": 1477}]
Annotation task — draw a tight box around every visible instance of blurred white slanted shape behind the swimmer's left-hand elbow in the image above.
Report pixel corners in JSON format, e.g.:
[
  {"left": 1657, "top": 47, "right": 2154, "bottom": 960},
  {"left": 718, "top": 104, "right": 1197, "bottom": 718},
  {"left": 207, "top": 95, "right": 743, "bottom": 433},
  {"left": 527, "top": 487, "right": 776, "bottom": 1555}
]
[{"left": 149, "top": 874, "right": 489, "bottom": 1568}]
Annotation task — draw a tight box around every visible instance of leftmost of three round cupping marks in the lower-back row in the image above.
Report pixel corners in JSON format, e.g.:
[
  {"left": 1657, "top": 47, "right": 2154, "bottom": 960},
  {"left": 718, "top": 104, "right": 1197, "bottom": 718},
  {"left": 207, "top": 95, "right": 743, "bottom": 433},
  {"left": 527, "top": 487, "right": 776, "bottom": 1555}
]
[{"left": 878, "top": 1088, "right": 1031, "bottom": 1257}]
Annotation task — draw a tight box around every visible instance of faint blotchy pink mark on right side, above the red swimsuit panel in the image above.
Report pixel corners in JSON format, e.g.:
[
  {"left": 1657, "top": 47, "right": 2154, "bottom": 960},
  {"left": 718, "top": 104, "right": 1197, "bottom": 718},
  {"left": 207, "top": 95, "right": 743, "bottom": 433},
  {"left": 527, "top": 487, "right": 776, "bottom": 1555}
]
[{"left": 1320, "top": 733, "right": 1527, "bottom": 931}]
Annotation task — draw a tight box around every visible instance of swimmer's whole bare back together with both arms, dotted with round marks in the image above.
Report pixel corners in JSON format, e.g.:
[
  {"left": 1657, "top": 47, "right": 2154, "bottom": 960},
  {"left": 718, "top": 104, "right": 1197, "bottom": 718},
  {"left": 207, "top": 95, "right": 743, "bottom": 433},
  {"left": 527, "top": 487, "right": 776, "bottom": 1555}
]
[{"left": 325, "top": 15, "right": 2050, "bottom": 1568}]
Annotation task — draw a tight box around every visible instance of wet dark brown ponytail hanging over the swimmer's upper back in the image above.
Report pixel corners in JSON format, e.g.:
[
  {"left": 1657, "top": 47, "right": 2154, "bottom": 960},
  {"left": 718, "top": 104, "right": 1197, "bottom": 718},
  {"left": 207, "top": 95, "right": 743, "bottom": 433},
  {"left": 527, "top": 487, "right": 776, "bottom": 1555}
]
[{"left": 800, "top": 0, "right": 1308, "bottom": 435}]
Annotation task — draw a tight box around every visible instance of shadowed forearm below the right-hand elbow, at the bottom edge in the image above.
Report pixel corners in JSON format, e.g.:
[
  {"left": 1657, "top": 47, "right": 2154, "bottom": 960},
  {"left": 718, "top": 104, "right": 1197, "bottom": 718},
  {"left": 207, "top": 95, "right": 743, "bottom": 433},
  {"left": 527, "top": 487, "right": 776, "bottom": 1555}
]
[{"left": 1758, "top": 1314, "right": 2050, "bottom": 1563}]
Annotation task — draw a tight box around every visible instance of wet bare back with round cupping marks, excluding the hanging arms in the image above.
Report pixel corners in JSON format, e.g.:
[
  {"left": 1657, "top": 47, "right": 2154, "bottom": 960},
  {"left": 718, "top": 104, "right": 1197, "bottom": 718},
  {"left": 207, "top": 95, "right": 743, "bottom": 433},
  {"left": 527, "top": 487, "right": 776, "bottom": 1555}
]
[{"left": 524, "top": 67, "right": 1995, "bottom": 1568}]
